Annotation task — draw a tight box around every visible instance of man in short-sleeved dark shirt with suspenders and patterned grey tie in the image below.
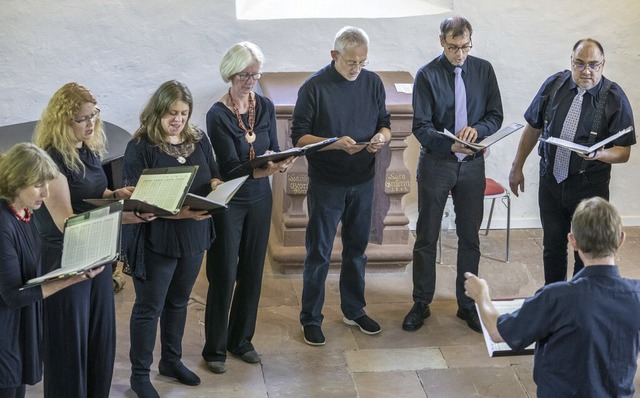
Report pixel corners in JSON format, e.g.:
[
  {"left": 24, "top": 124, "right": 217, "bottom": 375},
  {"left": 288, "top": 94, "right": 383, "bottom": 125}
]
[{"left": 509, "top": 39, "right": 636, "bottom": 284}]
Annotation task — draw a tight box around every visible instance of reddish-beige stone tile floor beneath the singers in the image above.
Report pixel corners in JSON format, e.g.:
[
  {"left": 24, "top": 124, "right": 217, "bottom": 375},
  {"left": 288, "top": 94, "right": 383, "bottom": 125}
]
[{"left": 27, "top": 228, "right": 640, "bottom": 398}]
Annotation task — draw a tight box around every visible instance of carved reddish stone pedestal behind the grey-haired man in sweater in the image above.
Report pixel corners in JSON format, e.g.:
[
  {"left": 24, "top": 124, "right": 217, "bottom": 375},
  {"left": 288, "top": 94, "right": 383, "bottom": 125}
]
[{"left": 260, "top": 72, "right": 414, "bottom": 272}]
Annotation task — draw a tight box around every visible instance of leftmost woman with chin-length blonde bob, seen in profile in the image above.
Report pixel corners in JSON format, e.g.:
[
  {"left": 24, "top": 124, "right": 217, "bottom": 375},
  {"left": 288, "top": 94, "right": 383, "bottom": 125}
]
[{"left": 0, "top": 143, "right": 104, "bottom": 398}]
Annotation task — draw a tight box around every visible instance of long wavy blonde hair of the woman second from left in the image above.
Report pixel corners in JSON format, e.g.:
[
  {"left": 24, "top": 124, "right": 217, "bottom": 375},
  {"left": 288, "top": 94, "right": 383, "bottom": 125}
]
[{"left": 33, "top": 83, "right": 107, "bottom": 172}]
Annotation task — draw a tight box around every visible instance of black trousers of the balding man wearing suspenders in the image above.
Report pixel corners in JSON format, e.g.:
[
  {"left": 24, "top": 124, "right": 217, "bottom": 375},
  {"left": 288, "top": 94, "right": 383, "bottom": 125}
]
[{"left": 538, "top": 171, "right": 610, "bottom": 284}]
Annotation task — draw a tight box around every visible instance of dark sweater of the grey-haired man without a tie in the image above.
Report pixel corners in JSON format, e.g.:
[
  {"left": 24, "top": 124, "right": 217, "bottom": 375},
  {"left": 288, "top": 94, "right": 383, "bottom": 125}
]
[{"left": 291, "top": 62, "right": 390, "bottom": 186}]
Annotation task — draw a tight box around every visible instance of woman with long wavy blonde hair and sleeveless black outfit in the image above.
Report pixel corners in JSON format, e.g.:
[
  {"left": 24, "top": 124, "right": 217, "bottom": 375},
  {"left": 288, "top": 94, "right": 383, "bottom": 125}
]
[{"left": 34, "top": 83, "right": 150, "bottom": 398}]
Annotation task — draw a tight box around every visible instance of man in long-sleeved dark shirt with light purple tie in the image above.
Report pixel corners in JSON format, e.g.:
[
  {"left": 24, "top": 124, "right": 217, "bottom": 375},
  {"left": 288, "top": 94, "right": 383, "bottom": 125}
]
[{"left": 402, "top": 16, "right": 503, "bottom": 332}]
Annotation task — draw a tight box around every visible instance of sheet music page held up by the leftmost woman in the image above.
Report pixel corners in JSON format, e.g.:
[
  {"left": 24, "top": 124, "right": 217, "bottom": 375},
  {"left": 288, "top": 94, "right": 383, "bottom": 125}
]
[{"left": 62, "top": 208, "right": 120, "bottom": 272}]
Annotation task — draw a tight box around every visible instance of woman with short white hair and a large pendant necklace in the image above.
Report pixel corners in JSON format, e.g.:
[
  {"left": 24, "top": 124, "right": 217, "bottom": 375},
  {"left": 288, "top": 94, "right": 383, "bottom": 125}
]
[{"left": 202, "top": 41, "right": 294, "bottom": 373}]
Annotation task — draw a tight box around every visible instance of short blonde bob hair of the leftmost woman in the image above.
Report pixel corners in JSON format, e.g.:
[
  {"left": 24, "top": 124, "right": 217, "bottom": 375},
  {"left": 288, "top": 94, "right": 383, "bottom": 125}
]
[{"left": 0, "top": 142, "right": 58, "bottom": 200}]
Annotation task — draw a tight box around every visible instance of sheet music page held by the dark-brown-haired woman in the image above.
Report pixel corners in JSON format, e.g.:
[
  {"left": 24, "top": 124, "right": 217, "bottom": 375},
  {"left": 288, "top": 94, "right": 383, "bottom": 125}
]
[{"left": 131, "top": 173, "right": 191, "bottom": 211}]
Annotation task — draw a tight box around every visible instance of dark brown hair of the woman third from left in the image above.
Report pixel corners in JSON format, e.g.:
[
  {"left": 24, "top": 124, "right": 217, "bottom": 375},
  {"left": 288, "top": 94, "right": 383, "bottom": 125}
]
[{"left": 133, "top": 80, "right": 202, "bottom": 151}]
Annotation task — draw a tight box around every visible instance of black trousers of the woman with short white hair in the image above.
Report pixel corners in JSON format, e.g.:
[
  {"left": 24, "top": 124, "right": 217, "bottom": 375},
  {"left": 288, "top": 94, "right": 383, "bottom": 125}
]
[{"left": 202, "top": 192, "right": 273, "bottom": 362}]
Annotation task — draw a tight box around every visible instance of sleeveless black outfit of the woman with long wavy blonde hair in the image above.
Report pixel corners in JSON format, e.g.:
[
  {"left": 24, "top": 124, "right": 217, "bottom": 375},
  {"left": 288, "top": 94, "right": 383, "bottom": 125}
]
[{"left": 36, "top": 146, "right": 116, "bottom": 398}]
